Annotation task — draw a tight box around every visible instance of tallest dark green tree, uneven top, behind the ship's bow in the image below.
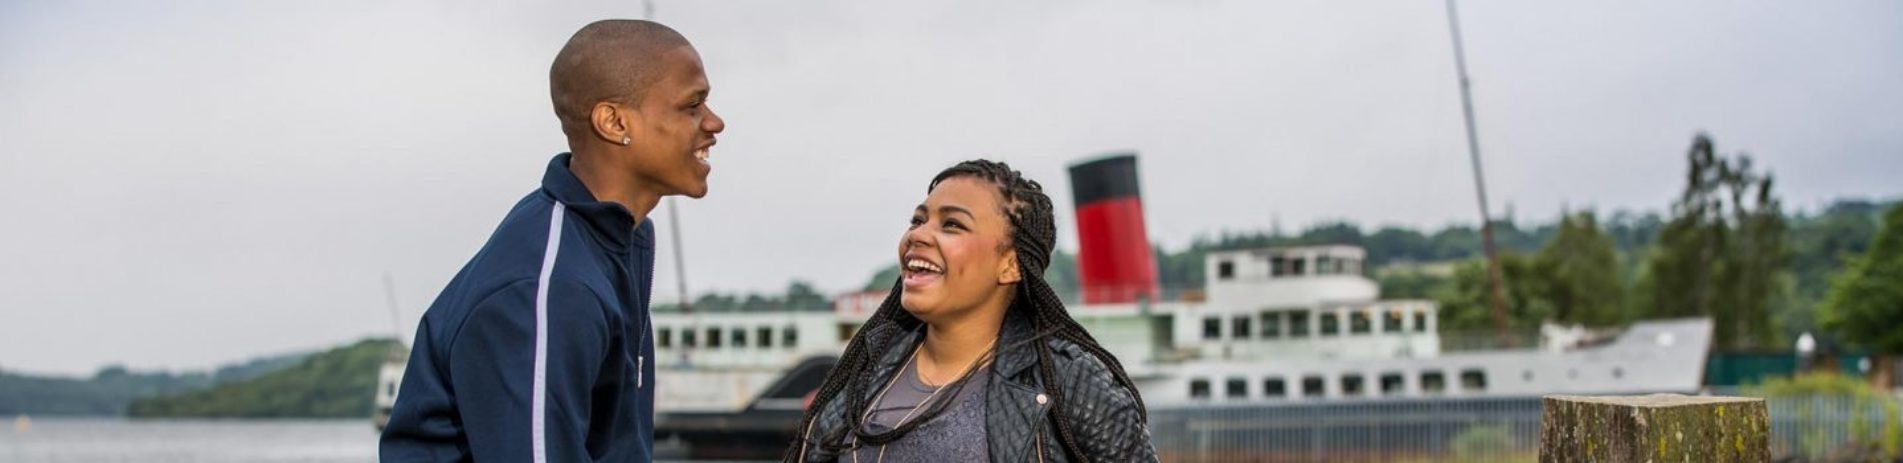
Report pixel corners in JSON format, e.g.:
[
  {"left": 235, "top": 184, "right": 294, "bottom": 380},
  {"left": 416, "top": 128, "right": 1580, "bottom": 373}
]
[{"left": 1640, "top": 133, "right": 1791, "bottom": 349}]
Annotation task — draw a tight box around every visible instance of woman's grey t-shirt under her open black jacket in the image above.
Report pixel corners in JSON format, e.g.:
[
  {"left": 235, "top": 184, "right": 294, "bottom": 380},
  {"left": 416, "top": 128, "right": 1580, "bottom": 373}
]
[{"left": 858, "top": 356, "right": 991, "bottom": 463}]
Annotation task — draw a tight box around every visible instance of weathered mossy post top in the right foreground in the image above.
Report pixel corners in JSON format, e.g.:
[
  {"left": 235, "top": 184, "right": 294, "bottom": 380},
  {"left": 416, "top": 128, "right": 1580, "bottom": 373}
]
[{"left": 1540, "top": 394, "right": 1772, "bottom": 463}]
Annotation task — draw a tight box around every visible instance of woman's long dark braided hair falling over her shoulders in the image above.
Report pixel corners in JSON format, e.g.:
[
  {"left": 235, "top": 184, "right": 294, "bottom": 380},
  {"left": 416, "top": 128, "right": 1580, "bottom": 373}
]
[{"left": 786, "top": 160, "right": 1149, "bottom": 461}]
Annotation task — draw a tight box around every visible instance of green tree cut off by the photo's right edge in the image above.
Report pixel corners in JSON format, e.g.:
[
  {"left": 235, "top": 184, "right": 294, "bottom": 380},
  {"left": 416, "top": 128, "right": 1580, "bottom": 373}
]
[{"left": 1817, "top": 206, "right": 1903, "bottom": 387}]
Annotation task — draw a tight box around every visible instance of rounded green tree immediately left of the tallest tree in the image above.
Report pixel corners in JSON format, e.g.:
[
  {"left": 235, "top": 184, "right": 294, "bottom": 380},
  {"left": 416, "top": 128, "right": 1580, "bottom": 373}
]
[{"left": 1532, "top": 211, "right": 1627, "bottom": 326}]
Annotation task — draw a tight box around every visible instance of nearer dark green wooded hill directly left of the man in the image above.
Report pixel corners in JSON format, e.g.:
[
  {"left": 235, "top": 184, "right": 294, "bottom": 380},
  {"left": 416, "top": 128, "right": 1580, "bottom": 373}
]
[{"left": 128, "top": 339, "right": 402, "bottom": 417}]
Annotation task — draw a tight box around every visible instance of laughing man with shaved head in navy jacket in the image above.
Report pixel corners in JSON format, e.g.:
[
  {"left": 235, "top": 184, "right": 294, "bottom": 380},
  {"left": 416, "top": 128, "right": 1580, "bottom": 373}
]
[{"left": 381, "top": 19, "right": 725, "bottom": 461}]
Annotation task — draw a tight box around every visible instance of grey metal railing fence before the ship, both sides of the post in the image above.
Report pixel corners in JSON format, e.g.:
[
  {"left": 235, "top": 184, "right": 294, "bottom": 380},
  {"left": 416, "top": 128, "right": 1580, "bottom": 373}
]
[{"left": 1149, "top": 396, "right": 1903, "bottom": 463}]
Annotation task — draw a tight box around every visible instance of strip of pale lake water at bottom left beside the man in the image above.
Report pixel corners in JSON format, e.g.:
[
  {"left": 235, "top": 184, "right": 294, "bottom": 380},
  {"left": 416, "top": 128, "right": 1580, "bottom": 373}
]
[{"left": 0, "top": 417, "right": 377, "bottom": 463}]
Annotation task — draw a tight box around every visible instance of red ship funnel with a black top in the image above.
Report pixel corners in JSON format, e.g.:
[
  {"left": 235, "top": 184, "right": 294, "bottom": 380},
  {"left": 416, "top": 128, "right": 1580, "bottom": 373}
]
[{"left": 1069, "top": 152, "right": 1159, "bottom": 305}]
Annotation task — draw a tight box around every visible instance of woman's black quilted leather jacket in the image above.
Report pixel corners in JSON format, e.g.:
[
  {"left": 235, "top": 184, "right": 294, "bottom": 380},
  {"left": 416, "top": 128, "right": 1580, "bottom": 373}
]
[{"left": 792, "top": 311, "right": 1157, "bottom": 463}]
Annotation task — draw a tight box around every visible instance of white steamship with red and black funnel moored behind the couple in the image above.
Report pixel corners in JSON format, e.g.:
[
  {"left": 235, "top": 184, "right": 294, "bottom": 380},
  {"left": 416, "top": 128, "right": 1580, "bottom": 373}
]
[{"left": 379, "top": 152, "right": 1713, "bottom": 457}]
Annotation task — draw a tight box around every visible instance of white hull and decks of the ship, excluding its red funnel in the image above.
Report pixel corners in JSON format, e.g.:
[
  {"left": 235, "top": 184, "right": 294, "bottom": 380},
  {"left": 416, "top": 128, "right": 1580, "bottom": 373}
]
[{"left": 635, "top": 246, "right": 1711, "bottom": 412}]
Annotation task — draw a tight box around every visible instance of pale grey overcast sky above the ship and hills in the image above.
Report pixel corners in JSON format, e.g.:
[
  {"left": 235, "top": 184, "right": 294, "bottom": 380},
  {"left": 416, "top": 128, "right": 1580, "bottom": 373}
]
[{"left": 0, "top": 0, "right": 1903, "bottom": 373}]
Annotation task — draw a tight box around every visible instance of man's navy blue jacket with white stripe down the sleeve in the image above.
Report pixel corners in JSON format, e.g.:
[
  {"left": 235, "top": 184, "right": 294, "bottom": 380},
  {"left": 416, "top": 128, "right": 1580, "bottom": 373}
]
[{"left": 381, "top": 152, "right": 655, "bottom": 461}]
